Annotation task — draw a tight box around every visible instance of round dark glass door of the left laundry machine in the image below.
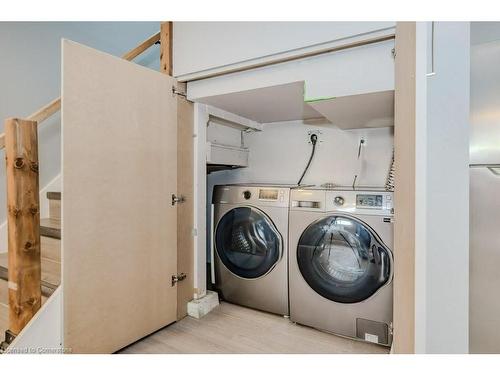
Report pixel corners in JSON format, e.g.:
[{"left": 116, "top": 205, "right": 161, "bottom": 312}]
[{"left": 215, "top": 207, "right": 282, "bottom": 279}]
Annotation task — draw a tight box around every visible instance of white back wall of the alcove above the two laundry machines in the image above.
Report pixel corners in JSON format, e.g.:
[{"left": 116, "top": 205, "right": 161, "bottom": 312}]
[{"left": 206, "top": 121, "right": 393, "bottom": 259}]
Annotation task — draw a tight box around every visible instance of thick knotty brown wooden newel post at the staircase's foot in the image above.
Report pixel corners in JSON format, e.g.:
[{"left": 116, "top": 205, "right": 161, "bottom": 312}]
[{"left": 5, "top": 118, "right": 42, "bottom": 337}]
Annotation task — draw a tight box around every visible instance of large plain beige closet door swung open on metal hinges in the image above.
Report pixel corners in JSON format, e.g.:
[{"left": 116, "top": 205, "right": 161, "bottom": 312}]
[{"left": 62, "top": 41, "right": 177, "bottom": 353}]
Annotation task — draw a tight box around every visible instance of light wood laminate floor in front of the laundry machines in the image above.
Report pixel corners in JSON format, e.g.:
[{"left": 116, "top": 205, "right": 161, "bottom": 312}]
[{"left": 119, "top": 302, "right": 389, "bottom": 354}]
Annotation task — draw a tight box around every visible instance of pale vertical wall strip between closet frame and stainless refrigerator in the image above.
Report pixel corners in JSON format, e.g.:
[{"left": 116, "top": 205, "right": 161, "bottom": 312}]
[{"left": 417, "top": 22, "right": 470, "bottom": 353}]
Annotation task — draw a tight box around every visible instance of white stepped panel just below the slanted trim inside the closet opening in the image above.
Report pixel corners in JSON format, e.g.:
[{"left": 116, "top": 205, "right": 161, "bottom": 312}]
[{"left": 187, "top": 40, "right": 394, "bottom": 101}]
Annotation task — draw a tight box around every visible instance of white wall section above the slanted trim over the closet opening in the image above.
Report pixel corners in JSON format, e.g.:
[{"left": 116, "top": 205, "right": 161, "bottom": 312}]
[{"left": 173, "top": 22, "right": 395, "bottom": 80}]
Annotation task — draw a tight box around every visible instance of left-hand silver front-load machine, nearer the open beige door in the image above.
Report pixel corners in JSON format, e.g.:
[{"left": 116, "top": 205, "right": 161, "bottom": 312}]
[{"left": 212, "top": 184, "right": 294, "bottom": 316}]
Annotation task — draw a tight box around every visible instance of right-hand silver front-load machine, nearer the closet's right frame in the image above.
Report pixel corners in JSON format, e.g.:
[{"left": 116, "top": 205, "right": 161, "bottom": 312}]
[{"left": 289, "top": 189, "right": 394, "bottom": 346}]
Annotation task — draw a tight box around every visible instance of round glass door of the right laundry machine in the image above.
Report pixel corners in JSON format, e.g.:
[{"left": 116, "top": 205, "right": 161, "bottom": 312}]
[{"left": 297, "top": 215, "right": 392, "bottom": 303}]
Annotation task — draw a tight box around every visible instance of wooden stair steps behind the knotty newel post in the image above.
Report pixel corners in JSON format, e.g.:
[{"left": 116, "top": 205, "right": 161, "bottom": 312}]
[{"left": 0, "top": 192, "right": 61, "bottom": 341}]
